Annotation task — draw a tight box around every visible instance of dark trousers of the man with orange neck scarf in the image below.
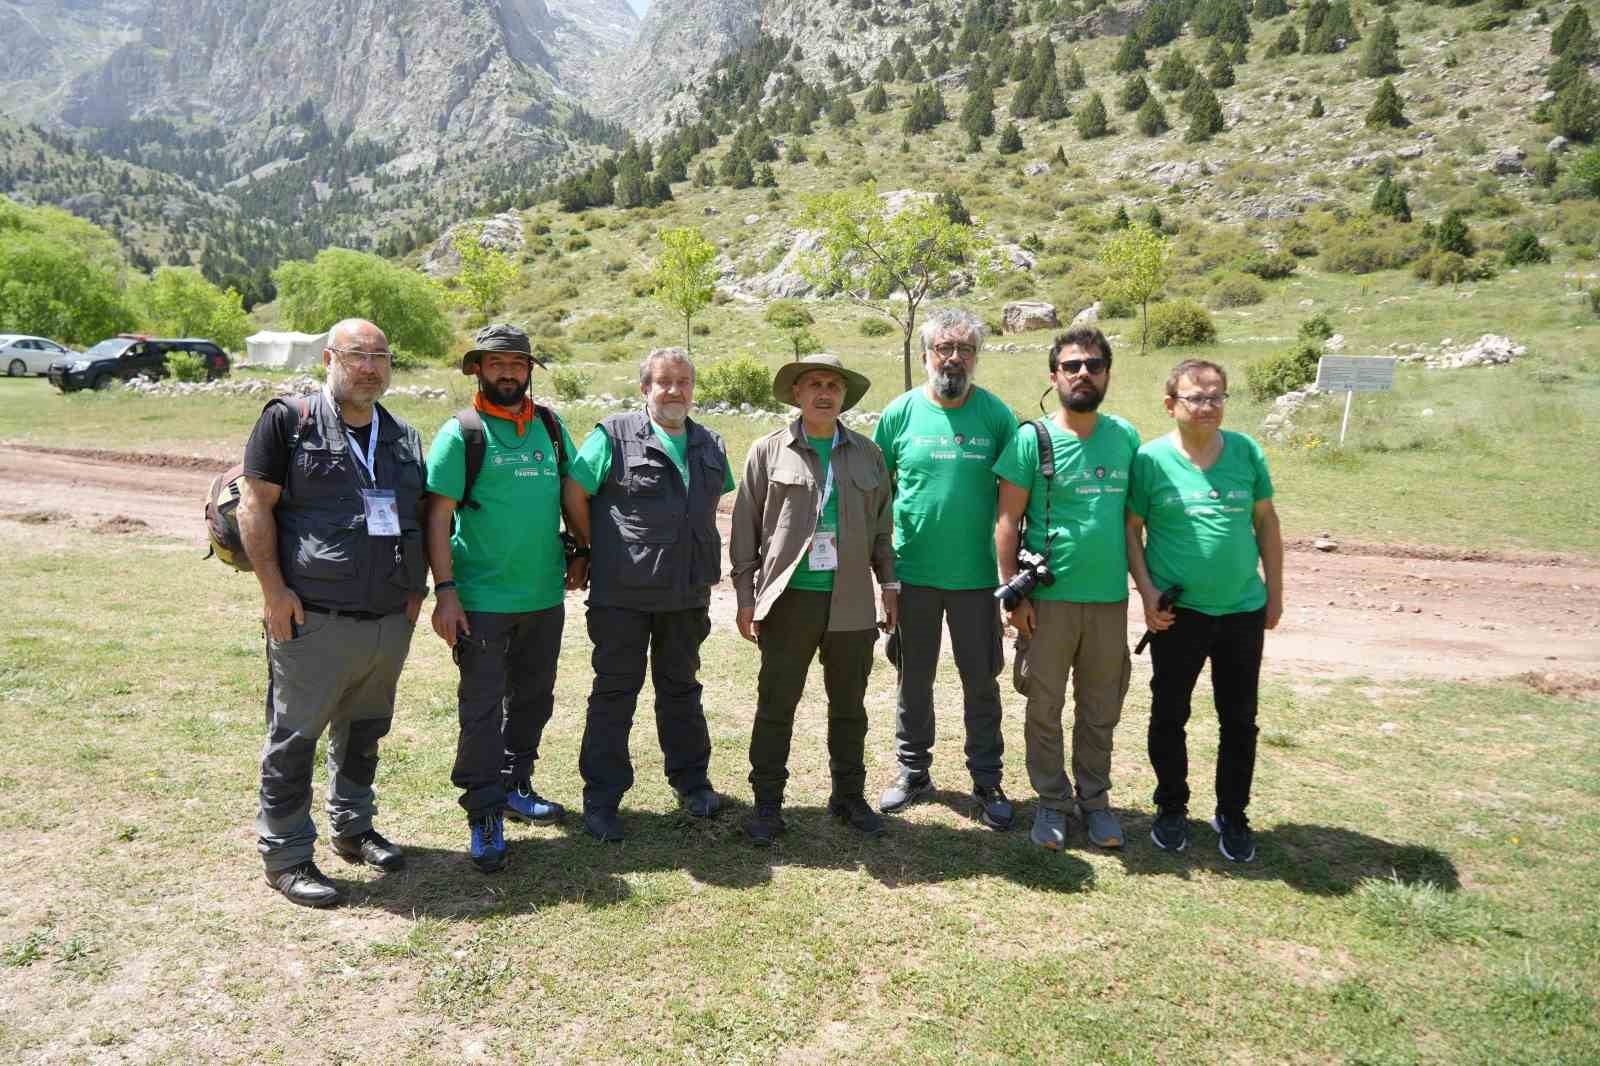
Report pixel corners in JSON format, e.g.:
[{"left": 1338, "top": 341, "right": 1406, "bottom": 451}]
[{"left": 450, "top": 603, "right": 566, "bottom": 815}]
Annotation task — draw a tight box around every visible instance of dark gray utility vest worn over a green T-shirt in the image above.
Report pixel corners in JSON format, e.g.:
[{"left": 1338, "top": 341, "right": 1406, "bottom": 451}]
[{"left": 589, "top": 411, "right": 728, "bottom": 611}]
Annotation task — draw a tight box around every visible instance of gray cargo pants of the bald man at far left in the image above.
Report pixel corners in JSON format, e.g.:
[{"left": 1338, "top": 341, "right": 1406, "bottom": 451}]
[{"left": 256, "top": 611, "right": 413, "bottom": 872}]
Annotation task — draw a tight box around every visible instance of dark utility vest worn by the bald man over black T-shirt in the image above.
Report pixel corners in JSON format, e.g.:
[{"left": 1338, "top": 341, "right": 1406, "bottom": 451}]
[{"left": 272, "top": 392, "right": 427, "bottom": 615}]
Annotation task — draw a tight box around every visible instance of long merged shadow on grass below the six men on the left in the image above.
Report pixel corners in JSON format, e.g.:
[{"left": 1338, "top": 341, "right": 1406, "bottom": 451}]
[{"left": 352, "top": 802, "right": 1094, "bottom": 919}]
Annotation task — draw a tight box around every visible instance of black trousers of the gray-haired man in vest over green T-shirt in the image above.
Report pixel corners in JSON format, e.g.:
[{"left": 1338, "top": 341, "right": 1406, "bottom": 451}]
[{"left": 578, "top": 607, "right": 710, "bottom": 808}]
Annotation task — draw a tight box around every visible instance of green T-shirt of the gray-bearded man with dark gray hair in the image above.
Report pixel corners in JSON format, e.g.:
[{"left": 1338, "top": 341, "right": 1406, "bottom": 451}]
[{"left": 872, "top": 387, "right": 1016, "bottom": 589}]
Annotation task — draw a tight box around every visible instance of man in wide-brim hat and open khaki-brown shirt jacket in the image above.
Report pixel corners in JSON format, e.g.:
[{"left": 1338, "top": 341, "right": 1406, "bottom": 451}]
[{"left": 730, "top": 354, "right": 899, "bottom": 844}]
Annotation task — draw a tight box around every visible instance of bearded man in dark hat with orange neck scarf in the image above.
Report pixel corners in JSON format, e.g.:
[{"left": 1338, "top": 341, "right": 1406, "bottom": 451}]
[{"left": 427, "top": 325, "right": 576, "bottom": 872}]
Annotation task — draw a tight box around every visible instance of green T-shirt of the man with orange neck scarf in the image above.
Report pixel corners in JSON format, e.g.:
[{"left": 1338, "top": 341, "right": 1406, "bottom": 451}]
[{"left": 427, "top": 415, "right": 573, "bottom": 615}]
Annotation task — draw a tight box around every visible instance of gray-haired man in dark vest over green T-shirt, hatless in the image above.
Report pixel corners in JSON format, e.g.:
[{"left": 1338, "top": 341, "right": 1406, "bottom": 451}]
[{"left": 563, "top": 347, "right": 734, "bottom": 840}]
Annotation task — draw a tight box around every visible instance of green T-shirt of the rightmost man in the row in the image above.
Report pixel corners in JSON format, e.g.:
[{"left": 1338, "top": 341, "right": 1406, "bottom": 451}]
[{"left": 1128, "top": 429, "right": 1272, "bottom": 615}]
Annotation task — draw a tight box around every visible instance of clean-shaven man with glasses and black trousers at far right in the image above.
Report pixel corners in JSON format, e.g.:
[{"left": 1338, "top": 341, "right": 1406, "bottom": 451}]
[{"left": 1126, "top": 359, "right": 1283, "bottom": 863}]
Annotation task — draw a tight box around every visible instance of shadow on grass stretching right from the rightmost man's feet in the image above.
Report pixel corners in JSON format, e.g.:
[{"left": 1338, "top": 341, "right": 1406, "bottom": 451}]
[{"left": 1118, "top": 815, "right": 1461, "bottom": 896}]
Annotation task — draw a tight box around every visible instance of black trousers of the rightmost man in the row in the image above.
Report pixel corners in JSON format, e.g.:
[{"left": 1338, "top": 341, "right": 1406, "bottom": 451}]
[{"left": 1149, "top": 608, "right": 1267, "bottom": 818}]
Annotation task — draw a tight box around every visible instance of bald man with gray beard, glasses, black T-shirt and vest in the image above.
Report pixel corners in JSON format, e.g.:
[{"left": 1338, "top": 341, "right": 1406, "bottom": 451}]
[{"left": 238, "top": 319, "right": 427, "bottom": 908}]
